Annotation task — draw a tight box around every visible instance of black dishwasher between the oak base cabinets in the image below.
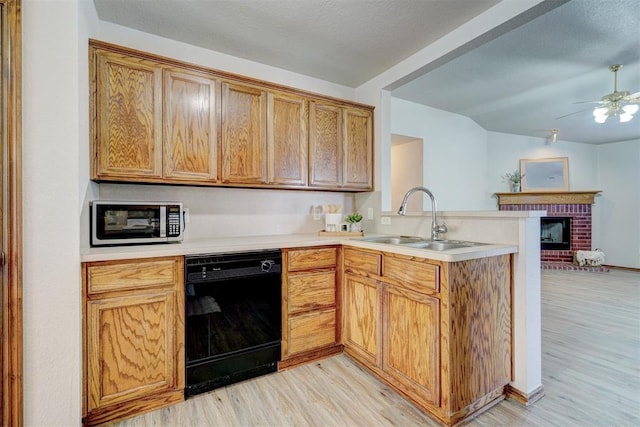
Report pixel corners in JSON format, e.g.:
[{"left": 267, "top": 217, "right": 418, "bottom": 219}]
[{"left": 185, "top": 250, "right": 282, "bottom": 397}]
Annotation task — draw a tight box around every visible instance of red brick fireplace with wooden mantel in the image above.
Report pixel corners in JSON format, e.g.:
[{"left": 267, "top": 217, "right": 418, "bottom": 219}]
[{"left": 496, "top": 191, "right": 599, "bottom": 267}]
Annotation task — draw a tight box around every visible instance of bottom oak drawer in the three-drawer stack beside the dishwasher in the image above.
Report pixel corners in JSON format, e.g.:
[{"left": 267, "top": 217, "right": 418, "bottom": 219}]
[{"left": 288, "top": 309, "right": 336, "bottom": 354}]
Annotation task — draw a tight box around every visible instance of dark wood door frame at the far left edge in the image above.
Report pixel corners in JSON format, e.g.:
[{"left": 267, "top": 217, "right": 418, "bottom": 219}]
[{"left": 0, "top": 0, "right": 23, "bottom": 426}]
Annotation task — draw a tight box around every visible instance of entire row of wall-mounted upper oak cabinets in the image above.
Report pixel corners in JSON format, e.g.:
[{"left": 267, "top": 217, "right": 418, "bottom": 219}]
[{"left": 89, "top": 40, "right": 373, "bottom": 191}]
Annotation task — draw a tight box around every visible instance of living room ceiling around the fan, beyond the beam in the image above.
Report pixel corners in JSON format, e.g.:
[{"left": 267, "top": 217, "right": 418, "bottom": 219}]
[{"left": 392, "top": 0, "right": 640, "bottom": 144}]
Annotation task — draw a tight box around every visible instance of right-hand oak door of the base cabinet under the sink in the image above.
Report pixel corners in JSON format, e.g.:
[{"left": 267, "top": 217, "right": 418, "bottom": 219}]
[{"left": 383, "top": 285, "right": 440, "bottom": 406}]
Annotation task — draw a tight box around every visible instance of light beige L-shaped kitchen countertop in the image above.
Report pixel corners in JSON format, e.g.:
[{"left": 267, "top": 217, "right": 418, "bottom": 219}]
[{"left": 80, "top": 234, "right": 518, "bottom": 262}]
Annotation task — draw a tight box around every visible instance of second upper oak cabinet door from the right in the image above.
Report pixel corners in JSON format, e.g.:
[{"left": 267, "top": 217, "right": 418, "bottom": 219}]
[{"left": 309, "top": 102, "right": 343, "bottom": 188}]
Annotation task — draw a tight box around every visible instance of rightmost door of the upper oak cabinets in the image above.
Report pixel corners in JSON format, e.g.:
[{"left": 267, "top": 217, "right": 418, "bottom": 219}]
[{"left": 343, "top": 108, "right": 373, "bottom": 190}]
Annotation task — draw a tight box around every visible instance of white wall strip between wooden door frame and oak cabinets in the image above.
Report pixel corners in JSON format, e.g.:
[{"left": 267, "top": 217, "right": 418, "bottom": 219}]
[{"left": 22, "top": 0, "right": 91, "bottom": 426}]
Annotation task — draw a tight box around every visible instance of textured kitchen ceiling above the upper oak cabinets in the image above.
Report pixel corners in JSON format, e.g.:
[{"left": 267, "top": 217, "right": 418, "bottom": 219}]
[{"left": 94, "top": 0, "right": 499, "bottom": 87}]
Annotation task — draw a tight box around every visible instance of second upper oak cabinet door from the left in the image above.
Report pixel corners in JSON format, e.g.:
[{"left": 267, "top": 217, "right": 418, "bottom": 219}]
[{"left": 163, "top": 70, "right": 218, "bottom": 182}]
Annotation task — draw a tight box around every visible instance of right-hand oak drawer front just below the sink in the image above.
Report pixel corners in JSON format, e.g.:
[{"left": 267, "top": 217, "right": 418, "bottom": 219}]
[{"left": 382, "top": 254, "right": 440, "bottom": 292}]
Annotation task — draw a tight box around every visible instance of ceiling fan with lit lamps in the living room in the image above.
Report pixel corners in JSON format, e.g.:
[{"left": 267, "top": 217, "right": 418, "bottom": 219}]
[{"left": 557, "top": 64, "right": 640, "bottom": 123}]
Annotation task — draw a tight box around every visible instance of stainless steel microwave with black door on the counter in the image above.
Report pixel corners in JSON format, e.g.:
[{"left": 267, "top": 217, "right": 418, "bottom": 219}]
[{"left": 90, "top": 200, "right": 184, "bottom": 246}]
